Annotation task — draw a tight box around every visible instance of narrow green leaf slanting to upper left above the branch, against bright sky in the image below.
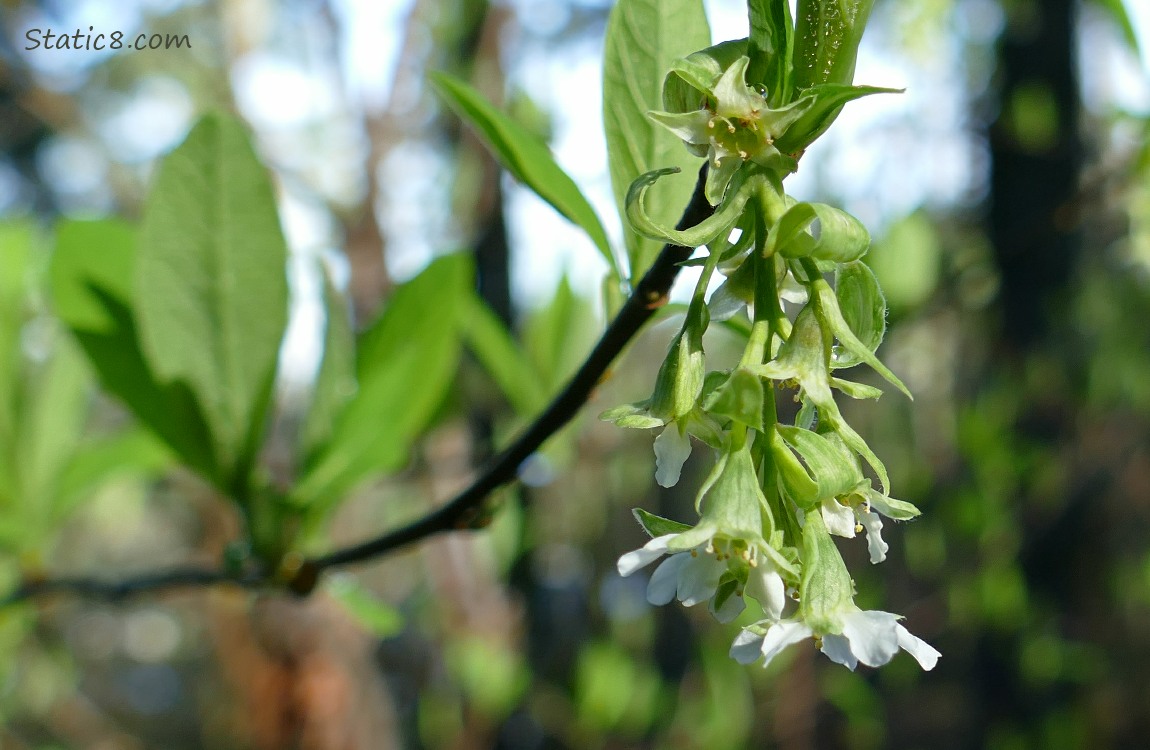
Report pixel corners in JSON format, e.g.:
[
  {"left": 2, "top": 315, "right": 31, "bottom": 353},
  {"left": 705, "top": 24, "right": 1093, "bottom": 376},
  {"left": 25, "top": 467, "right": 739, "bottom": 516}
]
[{"left": 430, "top": 72, "right": 621, "bottom": 278}]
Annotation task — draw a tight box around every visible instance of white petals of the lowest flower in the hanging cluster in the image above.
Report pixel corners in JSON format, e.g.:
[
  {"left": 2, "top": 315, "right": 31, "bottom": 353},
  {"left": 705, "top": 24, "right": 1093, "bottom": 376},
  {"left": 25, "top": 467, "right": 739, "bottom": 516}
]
[{"left": 730, "top": 604, "right": 942, "bottom": 671}]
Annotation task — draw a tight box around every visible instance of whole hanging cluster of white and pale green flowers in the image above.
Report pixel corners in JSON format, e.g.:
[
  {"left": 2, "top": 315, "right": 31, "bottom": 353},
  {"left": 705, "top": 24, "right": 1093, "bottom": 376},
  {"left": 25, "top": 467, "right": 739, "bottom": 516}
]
[{"left": 603, "top": 30, "right": 940, "bottom": 669}]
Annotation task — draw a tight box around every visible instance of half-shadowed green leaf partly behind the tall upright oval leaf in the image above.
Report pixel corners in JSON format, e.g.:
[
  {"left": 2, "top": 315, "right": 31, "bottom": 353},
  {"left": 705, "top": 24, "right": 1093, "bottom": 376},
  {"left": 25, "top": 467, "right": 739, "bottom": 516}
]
[{"left": 48, "top": 220, "right": 222, "bottom": 487}]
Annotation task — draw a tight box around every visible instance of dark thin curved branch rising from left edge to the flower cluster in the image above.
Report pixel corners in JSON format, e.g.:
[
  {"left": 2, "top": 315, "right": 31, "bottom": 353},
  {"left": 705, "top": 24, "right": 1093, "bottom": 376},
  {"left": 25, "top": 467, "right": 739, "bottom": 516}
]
[{"left": 0, "top": 166, "right": 714, "bottom": 606}]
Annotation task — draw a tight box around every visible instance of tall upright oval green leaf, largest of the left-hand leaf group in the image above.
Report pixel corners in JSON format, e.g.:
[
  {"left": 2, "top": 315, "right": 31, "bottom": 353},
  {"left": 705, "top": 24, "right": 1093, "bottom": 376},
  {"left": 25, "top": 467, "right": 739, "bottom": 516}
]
[{"left": 136, "top": 115, "right": 288, "bottom": 497}]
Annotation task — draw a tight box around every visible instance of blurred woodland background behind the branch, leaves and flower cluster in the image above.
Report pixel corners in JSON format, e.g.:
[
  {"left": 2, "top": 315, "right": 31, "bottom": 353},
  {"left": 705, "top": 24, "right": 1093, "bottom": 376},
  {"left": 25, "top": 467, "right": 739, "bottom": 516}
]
[{"left": 0, "top": 0, "right": 1150, "bottom": 750}]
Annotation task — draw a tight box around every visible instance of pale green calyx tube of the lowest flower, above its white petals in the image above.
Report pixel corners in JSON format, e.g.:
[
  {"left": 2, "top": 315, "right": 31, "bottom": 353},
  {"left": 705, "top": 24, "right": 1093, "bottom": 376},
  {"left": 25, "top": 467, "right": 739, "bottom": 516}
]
[{"left": 798, "top": 508, "right": 854, "bottom": 635}]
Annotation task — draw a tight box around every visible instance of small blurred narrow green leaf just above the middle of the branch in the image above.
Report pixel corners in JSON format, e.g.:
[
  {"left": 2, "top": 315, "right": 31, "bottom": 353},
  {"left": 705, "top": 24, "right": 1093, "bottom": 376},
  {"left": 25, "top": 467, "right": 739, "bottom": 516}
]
[{"left": 461, "top": 293, "right": 547, "bottom": 416}]
